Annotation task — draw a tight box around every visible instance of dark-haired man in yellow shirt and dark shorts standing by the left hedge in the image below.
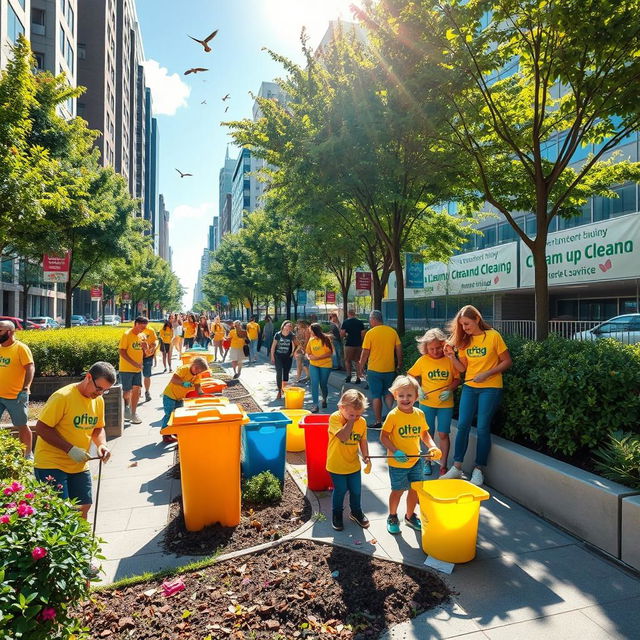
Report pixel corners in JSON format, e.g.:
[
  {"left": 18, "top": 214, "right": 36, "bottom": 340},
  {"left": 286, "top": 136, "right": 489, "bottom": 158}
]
[{"left": 118, "top": 316, "right": 149, "bottom": 424}]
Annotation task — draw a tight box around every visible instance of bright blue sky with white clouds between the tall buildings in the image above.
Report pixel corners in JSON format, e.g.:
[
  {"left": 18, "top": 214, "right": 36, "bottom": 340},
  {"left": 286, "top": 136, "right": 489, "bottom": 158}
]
[{"left": 137, "top": 0, "right": 359, "bottom": 308}]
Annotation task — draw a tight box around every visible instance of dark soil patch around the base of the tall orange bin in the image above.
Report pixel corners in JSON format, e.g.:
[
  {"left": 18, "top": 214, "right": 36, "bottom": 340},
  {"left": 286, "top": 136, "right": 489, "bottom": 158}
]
[{"left": 164, "top": 474, "right": 312, "bottom": 555}]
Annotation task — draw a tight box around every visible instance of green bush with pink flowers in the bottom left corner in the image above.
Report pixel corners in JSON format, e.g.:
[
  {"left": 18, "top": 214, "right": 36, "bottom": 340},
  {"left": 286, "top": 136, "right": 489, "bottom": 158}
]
[{"left": 0, "top": 478, "right": 101, "bottom": 640}]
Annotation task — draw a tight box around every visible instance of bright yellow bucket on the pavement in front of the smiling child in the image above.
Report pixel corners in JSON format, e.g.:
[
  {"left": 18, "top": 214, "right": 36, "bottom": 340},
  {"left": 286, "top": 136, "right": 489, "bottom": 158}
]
[{"left": 411, "top": 480, "right": 490, "bottom": 563}]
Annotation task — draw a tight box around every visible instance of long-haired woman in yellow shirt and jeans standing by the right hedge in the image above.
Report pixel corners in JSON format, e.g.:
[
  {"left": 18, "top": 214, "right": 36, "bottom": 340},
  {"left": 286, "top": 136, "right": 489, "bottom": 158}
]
[{"left": 442, "top": 305, "right": 512, "bottom": 486}]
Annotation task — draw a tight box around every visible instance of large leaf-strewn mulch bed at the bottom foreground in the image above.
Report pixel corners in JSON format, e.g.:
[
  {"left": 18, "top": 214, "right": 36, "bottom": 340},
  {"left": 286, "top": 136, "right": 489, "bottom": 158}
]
[{"left": 86, "top": 540, "right": 450, "bottom": 640}]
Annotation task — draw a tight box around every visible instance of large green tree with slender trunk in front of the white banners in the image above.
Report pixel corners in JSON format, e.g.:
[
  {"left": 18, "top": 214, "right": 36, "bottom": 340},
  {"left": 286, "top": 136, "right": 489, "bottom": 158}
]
[{"left": 370, "top": 0, "right": 640, "bottom": 340}]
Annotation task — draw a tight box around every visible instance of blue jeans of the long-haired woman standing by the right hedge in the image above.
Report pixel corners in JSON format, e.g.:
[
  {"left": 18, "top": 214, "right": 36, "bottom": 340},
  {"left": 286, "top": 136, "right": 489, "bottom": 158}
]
[{"left": 453, "top": 384, "right": 502, "bottom": 467}]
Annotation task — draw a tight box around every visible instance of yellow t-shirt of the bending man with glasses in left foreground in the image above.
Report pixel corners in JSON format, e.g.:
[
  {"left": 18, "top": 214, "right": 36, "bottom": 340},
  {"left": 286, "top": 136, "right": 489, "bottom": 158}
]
[{"left": 33, "top": 383, "right": 104, "bottom": 473}]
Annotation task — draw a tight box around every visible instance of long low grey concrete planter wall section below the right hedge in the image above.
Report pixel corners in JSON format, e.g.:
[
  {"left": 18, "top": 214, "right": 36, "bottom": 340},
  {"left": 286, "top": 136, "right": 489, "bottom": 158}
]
[{"left": 451, "top": 428, "right": 640, "bottom": 559}]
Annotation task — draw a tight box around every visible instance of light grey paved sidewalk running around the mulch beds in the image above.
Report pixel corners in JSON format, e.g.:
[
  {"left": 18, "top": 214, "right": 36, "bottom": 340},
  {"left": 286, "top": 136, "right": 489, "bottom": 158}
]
[{"left": 90, "top": 352, "right": 640, "bottom": 640}]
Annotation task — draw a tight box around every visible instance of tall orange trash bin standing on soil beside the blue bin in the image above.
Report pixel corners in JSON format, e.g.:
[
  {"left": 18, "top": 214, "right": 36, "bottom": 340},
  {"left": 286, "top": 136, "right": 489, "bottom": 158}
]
[{"left": 160, "top": 404, "right": 249, "bottom": 531}]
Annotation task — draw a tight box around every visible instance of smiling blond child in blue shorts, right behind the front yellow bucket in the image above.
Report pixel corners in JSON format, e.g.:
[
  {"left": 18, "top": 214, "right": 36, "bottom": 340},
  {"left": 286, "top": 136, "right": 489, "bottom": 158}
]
[{"left": 380, "top": 376, "right": 442, "bottom": 534}]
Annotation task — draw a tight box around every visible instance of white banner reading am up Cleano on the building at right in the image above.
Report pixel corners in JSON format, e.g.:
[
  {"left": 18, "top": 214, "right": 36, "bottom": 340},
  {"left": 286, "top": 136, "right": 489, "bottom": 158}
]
[{"left": 520, "top": 213, "right": 640, "bottom": 287}]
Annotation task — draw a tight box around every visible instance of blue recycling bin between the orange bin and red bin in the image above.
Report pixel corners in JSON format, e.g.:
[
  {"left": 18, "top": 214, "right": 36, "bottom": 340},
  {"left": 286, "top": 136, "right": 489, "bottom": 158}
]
[{"left": 240, "top": 412, "right": 291, "bottom": 484}]
